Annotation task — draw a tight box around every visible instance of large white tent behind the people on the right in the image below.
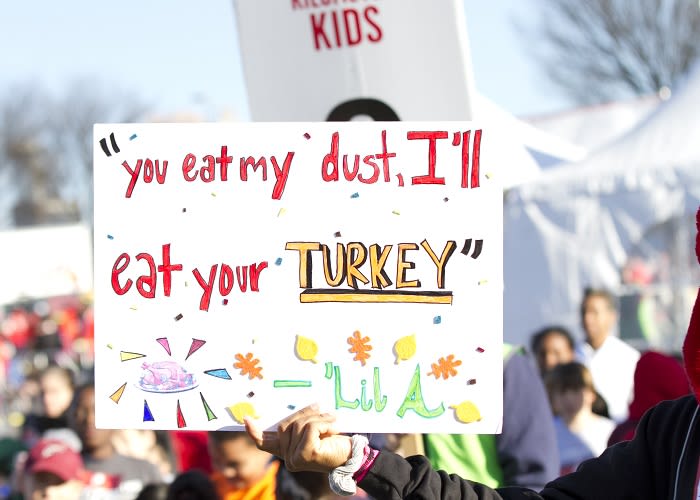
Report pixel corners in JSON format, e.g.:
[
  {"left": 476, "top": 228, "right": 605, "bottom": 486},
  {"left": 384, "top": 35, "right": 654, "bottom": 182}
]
[{"left": 504, "top": 64, "right": 700, "bottom": 348}]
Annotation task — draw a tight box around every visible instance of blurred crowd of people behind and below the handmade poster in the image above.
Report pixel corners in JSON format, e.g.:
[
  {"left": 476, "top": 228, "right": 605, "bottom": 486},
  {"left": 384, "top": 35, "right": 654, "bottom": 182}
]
[{"left": 0, "top": 256, "right": 697, "bottom": 500}]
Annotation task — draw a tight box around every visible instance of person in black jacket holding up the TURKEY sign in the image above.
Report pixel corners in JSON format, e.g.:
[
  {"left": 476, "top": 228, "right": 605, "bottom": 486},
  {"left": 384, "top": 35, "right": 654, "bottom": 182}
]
[{"left": 246, "top": 204, "right": 700, "bottom": 500}]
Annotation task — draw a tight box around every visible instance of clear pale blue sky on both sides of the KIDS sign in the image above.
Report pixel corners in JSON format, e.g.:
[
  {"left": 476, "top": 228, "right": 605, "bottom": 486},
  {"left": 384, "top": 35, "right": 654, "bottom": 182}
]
[{"left": 0, "top": 0, "right": 571, "bottom": 120}]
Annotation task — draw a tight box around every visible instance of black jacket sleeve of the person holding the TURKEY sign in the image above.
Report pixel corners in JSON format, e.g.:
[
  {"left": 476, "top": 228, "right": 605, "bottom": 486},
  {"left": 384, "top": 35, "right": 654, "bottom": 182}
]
[{"left": 360, "top": 396, "right": 700, "bottom": 500}]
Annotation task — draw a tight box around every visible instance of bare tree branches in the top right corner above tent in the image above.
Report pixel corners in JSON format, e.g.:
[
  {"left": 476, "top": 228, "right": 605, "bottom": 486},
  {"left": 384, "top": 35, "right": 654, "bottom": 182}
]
[{"left": 538, "top": 0, "right": 700, "bottom": 104}]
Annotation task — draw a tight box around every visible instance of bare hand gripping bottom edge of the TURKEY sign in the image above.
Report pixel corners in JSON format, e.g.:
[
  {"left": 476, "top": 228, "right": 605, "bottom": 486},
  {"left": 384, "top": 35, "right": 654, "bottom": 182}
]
[{"left": 245, "top": 404, "right": 352, "bottom": 472}]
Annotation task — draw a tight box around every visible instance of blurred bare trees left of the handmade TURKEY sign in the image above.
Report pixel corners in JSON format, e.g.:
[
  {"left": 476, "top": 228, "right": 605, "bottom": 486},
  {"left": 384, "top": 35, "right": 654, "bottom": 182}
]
[{"left": 0, "top": 81, "right": 146, "bottom": 227}]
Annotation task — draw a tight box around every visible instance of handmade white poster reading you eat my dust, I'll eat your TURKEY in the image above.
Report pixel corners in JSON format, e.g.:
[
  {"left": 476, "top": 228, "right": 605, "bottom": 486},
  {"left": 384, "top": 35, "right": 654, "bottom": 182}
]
[{"left": 94, "top": 122, "right": 503, "bottom": 433}]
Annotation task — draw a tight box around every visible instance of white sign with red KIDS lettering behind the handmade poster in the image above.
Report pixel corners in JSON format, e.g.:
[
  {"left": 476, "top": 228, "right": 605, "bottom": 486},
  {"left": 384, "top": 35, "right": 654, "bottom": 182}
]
[{"left": 234, "top": 0, "right": 474, "bottom": 121}]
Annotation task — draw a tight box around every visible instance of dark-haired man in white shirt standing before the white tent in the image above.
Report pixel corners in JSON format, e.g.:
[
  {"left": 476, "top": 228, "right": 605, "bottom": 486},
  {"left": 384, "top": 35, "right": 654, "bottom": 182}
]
[{"left": 577, "top": 288, "right": 640, "bottom": 422}]
